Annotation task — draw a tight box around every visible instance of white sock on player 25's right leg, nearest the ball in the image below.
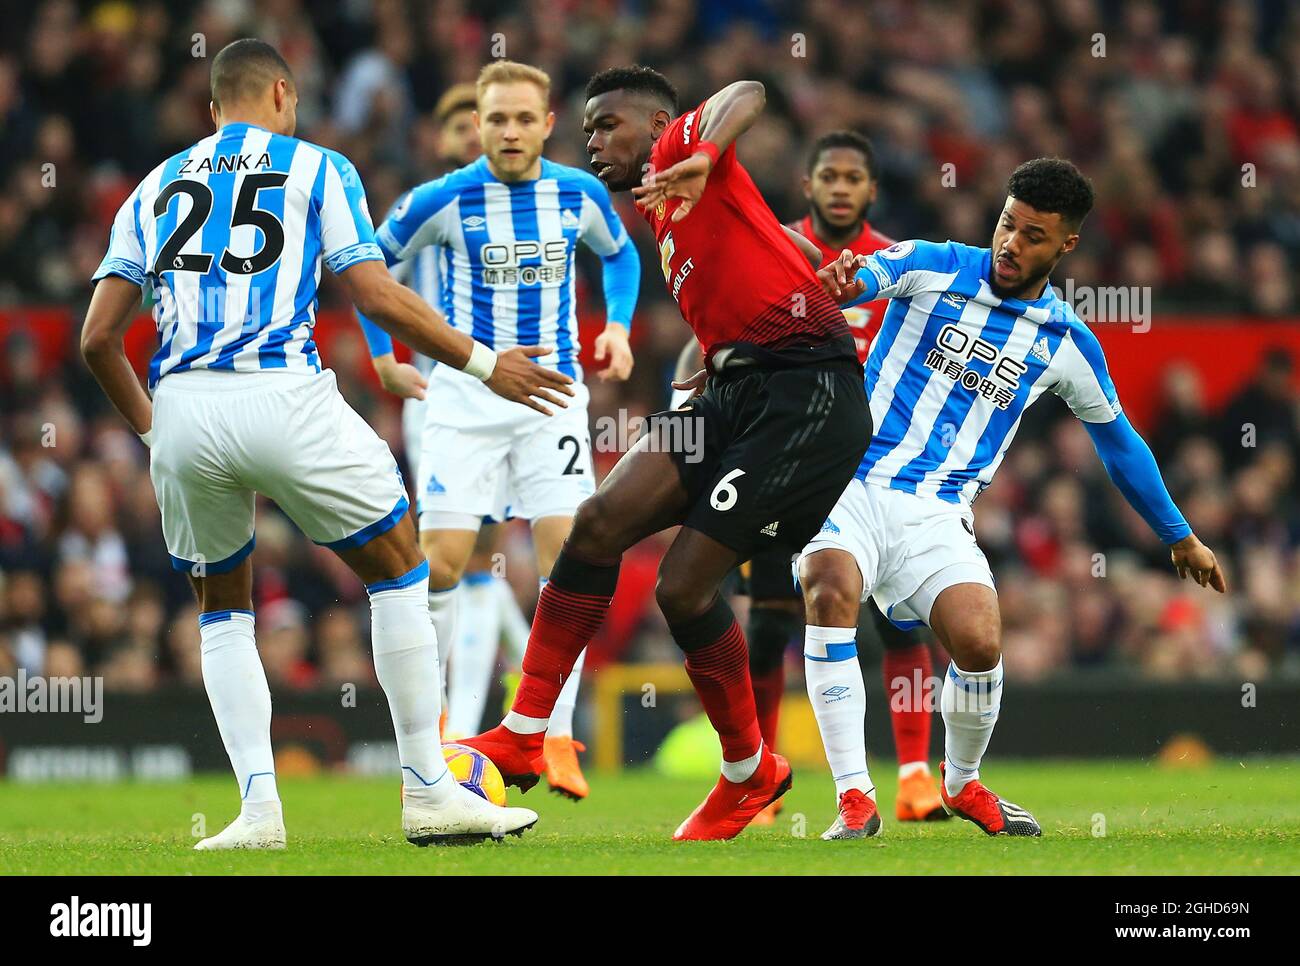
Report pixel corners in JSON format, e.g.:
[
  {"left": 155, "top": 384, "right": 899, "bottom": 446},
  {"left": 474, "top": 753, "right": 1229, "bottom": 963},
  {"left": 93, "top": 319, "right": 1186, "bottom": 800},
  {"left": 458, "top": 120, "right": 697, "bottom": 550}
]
[{"left": 365, "top": 563, "right": 454, "bottom": 801}]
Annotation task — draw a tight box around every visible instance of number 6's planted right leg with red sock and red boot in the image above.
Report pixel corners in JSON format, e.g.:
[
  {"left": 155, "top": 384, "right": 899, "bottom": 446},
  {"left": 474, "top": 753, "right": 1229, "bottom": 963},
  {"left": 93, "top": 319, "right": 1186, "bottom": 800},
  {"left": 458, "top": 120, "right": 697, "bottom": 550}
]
[{"left": 655, "top": 527, "right": 792, "bottom": 841}]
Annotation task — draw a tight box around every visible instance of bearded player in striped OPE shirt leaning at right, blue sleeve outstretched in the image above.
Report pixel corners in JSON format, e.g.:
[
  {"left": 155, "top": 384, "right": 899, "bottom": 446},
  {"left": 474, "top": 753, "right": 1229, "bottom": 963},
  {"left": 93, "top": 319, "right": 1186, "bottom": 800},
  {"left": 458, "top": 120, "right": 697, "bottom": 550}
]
[{"left": 798, "top": 157, "right": 1226, "bottom": 839}]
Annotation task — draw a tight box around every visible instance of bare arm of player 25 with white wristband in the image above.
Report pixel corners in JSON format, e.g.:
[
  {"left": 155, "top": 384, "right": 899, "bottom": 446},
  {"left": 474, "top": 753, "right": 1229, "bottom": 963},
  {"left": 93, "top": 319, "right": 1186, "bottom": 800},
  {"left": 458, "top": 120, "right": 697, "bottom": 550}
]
[{"left": 338, "top": 260, "right": 573, "bottom": 416}]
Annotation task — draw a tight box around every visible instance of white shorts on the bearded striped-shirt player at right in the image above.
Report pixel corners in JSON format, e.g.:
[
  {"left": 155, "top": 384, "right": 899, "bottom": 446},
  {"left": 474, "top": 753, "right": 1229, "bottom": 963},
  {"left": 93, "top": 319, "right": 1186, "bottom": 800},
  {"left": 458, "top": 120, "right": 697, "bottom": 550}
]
[{"left": 793, "top": 480, "right": 996, "bottom": 629}]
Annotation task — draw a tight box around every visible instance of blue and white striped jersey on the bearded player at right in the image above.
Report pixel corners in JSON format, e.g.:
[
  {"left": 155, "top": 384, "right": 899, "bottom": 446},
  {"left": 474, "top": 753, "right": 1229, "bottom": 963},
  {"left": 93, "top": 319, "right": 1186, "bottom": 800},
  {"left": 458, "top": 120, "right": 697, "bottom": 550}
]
[{"left": 854, "top": 241, "right": 1123, "bottom": 503}]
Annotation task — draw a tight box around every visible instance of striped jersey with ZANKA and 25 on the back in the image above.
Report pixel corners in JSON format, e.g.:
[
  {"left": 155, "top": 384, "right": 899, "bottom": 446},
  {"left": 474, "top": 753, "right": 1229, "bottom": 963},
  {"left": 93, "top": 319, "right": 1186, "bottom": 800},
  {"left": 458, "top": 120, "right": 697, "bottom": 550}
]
[{"left": 94, "top": 124, "right": 384, "bottom": 389}]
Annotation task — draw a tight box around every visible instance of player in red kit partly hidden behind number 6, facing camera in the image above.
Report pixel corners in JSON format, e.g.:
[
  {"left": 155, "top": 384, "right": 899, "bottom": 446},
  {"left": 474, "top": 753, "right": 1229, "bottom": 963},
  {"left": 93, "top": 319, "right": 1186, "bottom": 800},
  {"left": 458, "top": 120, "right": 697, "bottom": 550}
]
[{"left": 748, "top": 131, "right": 948, "bottom": 824}]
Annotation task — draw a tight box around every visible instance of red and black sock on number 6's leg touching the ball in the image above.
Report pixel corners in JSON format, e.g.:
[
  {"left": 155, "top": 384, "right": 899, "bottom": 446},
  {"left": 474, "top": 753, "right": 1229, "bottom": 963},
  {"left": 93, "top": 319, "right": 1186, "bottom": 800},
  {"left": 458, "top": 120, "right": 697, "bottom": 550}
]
[{"left": 511, "top": 549, "right": 619, "bottom": 718}]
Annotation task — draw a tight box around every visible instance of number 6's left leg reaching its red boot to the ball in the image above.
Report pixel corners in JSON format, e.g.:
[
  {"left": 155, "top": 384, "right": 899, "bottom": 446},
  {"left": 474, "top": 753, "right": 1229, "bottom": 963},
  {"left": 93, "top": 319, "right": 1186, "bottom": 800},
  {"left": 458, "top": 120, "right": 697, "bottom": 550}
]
[{"left": 462, "top": 436, "right": 686, "bottom": 792}]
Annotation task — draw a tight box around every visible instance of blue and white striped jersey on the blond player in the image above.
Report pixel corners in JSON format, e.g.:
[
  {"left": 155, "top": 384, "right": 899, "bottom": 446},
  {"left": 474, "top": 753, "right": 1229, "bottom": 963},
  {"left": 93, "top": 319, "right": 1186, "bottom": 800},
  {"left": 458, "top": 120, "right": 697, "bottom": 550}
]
[{"left": 363, "top": 157, "right": 641, "bottom": 377}]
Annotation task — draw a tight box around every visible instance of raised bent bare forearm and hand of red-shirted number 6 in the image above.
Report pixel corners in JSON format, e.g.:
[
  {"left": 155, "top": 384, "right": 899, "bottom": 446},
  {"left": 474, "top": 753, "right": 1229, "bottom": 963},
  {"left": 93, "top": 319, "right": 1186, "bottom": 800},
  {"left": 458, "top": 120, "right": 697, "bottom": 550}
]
[{"left": 632, "top": 81, "right": 767, "bottom": 221}]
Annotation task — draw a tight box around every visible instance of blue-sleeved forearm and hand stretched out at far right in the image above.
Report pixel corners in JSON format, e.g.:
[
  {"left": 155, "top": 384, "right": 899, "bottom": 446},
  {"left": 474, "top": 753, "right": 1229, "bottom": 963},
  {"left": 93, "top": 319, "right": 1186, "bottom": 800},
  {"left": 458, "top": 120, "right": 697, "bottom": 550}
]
[{"left": 1083, "top": 413, "right": 1227, "bottom": 594}]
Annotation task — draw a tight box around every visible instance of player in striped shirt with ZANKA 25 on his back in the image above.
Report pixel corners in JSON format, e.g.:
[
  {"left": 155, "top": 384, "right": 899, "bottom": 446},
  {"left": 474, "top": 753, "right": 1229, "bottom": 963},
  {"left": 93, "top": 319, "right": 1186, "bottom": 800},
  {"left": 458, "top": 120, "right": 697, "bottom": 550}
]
[{"left": 82, "top": 39, "right": 571, "bottom": 850}]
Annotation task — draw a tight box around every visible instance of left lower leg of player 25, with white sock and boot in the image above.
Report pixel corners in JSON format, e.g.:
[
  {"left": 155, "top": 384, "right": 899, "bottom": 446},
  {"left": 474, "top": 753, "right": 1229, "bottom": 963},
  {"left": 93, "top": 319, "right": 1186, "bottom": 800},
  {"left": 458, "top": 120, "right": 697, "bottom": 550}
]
[{"left": 190, "top": 556, "right": 285, "bottom": 852}]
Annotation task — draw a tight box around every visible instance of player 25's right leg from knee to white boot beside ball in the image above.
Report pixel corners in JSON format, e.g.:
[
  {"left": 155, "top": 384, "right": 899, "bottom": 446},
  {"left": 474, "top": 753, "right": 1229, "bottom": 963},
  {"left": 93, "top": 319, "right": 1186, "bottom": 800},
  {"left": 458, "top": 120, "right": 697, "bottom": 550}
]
[{"left": 339, "top": 515, "right": 537, "bottom": 845}]
